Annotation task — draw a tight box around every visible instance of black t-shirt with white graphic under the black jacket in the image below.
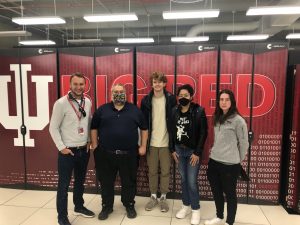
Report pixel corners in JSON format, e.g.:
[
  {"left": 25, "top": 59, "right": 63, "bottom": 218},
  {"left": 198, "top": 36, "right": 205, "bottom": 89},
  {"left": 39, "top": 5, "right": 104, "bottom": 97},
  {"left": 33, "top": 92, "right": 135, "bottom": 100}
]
[{"left": 176, "top": 111, "right": 191, "bottom": 146}]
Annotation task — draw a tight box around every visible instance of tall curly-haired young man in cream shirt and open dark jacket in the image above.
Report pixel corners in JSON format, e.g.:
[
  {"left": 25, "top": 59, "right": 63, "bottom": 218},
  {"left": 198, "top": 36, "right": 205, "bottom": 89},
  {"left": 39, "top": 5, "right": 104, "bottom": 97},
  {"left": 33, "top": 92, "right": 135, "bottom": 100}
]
[{"left": 141, "top": 72, "right": 176, "bottom": 212}]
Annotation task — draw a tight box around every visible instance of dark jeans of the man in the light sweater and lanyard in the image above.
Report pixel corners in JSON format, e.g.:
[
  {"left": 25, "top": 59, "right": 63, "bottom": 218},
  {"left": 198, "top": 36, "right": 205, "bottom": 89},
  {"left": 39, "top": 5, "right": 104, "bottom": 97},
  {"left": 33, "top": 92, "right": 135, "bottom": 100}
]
[{"left": 56, "top": 149, "right": 90, "bottom": 219}]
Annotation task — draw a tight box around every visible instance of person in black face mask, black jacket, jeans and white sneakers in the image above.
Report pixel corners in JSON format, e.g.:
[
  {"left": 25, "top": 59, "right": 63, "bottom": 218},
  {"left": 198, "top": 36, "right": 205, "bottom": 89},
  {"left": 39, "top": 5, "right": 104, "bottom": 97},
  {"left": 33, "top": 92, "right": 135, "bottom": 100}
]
[{"left": 170, "top": 84, "right": 207, "bottom": 225}]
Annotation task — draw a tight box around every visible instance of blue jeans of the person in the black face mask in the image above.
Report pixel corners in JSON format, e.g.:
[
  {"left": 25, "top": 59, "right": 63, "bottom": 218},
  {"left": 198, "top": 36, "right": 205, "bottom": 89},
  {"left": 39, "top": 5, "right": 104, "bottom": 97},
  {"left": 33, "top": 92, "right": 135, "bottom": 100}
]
[{"left": 175, "top": 145, "right": 200, "bottom": 210}]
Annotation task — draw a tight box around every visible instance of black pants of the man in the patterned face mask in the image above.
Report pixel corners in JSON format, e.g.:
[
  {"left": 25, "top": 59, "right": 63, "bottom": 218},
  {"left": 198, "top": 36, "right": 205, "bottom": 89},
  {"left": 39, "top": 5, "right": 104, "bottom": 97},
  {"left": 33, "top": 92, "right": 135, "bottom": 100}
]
[{"left": 94, "top": 147, "right": 137, "bottom": 208}]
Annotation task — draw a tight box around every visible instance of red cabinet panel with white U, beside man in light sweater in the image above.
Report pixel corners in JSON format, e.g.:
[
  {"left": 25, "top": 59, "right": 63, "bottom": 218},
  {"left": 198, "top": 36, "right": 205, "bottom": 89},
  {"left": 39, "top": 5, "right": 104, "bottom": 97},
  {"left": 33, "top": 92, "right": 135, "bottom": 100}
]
[{"left": 21, "top": 48, "right": 57, "bottom": 188}]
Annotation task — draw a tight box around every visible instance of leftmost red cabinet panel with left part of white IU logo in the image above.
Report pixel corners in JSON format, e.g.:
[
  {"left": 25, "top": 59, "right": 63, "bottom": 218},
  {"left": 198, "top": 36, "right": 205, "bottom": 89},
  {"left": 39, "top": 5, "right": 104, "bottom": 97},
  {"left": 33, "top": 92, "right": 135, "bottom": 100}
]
[{"left": 0, "top": 49, "right": 25, "bottom": 188}]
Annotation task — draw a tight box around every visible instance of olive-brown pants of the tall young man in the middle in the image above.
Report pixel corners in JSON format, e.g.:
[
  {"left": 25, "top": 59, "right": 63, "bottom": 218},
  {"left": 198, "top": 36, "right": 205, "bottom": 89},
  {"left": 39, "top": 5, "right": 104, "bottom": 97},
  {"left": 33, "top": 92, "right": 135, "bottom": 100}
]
[{"left": 147, "top": 146, "right": 171, "bottom": 194}]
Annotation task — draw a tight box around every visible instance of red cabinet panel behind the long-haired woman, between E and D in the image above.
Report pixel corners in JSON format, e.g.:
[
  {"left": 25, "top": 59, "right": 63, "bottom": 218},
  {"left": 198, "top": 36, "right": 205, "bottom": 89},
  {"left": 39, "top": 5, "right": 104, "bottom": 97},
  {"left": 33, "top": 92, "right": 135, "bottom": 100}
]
[{"left": 219, "top": 44, "right": 254, "bottom": 201}]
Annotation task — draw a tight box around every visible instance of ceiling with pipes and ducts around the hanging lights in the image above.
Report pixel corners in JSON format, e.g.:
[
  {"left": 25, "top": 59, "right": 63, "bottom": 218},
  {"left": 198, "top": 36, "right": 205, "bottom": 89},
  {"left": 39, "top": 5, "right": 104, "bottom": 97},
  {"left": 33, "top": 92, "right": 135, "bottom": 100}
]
[{"left": 0, "top": 0, "right": 300, "bottom": 48}]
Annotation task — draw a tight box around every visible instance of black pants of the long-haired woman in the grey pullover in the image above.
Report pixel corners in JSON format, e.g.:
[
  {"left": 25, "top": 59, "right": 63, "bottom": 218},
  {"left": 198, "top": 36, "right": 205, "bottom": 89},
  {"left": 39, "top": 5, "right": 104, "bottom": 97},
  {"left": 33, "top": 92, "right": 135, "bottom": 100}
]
[{"left": 207, "top": 159, "right": 240, "bottom": 224}]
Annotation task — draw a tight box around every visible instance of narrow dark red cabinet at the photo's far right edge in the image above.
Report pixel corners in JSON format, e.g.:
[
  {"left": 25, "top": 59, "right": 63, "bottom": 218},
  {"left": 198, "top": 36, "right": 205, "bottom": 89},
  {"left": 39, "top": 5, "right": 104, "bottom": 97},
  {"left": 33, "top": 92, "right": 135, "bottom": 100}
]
[{"left": 281, "top": 57, "right": 300, "bottom": 214}]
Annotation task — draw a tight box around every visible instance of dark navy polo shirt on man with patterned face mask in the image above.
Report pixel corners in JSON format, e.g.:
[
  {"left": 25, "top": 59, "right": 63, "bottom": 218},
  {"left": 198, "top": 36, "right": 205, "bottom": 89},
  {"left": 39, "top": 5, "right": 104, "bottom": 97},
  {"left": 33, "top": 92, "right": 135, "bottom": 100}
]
[{"left": 91, "top": 102, "right": 148, "bottom": 151}]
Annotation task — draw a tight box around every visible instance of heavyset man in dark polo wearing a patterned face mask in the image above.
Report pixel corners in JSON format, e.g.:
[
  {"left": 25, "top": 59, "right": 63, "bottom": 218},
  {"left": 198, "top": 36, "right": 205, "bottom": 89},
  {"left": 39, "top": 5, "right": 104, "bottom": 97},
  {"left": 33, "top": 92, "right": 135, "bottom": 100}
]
[{"left": 91, "top": 84, "right": 148, "bottom": 220}]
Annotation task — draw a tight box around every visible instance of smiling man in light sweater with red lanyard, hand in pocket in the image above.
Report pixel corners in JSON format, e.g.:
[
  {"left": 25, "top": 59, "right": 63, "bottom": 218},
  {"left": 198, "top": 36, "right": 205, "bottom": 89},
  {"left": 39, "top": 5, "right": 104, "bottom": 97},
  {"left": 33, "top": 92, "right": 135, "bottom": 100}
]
[{"left": 49, "top": 72, "right": 95, "bottom": 225}]
